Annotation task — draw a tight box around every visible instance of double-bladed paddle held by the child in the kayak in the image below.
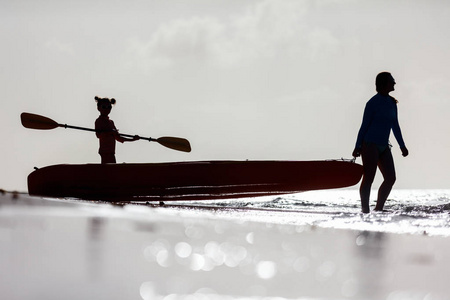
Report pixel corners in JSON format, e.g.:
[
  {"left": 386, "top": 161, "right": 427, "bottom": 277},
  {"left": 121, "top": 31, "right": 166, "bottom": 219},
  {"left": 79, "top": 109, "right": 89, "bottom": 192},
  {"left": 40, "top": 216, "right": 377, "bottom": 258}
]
[{"left": 20, "top": 112, "right": 191, "bottom": 152}]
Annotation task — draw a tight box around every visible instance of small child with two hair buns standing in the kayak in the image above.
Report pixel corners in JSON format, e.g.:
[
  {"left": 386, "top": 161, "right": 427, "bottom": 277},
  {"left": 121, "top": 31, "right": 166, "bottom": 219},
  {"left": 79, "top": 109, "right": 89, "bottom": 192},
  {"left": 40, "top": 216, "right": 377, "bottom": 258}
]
[{"left": 95, "top": 96, "right": 139, "bottom": 164}]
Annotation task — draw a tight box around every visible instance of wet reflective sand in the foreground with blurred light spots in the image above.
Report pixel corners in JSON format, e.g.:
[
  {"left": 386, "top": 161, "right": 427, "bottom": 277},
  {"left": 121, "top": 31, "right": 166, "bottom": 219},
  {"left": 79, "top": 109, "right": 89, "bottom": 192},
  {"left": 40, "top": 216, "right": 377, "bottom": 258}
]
[{"left": 0, "top": 193, "right": 450, "bottom": 300}]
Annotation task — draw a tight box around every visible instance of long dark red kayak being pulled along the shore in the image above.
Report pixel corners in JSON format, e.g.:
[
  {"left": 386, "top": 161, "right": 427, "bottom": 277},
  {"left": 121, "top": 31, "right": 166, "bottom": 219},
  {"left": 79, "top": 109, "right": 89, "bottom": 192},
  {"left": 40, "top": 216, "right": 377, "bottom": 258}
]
[{"left": 28, "top": 160, "right": 363, "bottom": 201}]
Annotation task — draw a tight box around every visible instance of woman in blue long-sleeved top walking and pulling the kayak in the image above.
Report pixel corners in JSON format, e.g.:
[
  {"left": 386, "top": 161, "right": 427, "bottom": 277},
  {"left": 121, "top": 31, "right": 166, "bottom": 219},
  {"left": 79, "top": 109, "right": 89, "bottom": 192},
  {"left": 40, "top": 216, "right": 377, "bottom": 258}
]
[{"left": 353, "top": 72, "right": 408, "bottom": 213}]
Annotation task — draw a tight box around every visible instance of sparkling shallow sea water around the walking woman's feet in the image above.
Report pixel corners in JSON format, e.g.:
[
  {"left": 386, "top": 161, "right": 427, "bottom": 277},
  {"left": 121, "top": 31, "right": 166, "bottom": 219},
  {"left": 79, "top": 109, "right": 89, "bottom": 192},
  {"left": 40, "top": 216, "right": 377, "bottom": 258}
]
[{"left": 153, "top": 189, "right": 450, "bottom": 236}]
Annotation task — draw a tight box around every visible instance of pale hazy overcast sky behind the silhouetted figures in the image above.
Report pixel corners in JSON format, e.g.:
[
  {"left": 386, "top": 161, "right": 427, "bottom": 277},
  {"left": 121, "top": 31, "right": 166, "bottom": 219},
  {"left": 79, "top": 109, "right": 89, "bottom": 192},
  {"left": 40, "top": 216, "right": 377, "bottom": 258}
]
[{"left": 0, "top": 0, "right": 450, "bottom": 191}]
